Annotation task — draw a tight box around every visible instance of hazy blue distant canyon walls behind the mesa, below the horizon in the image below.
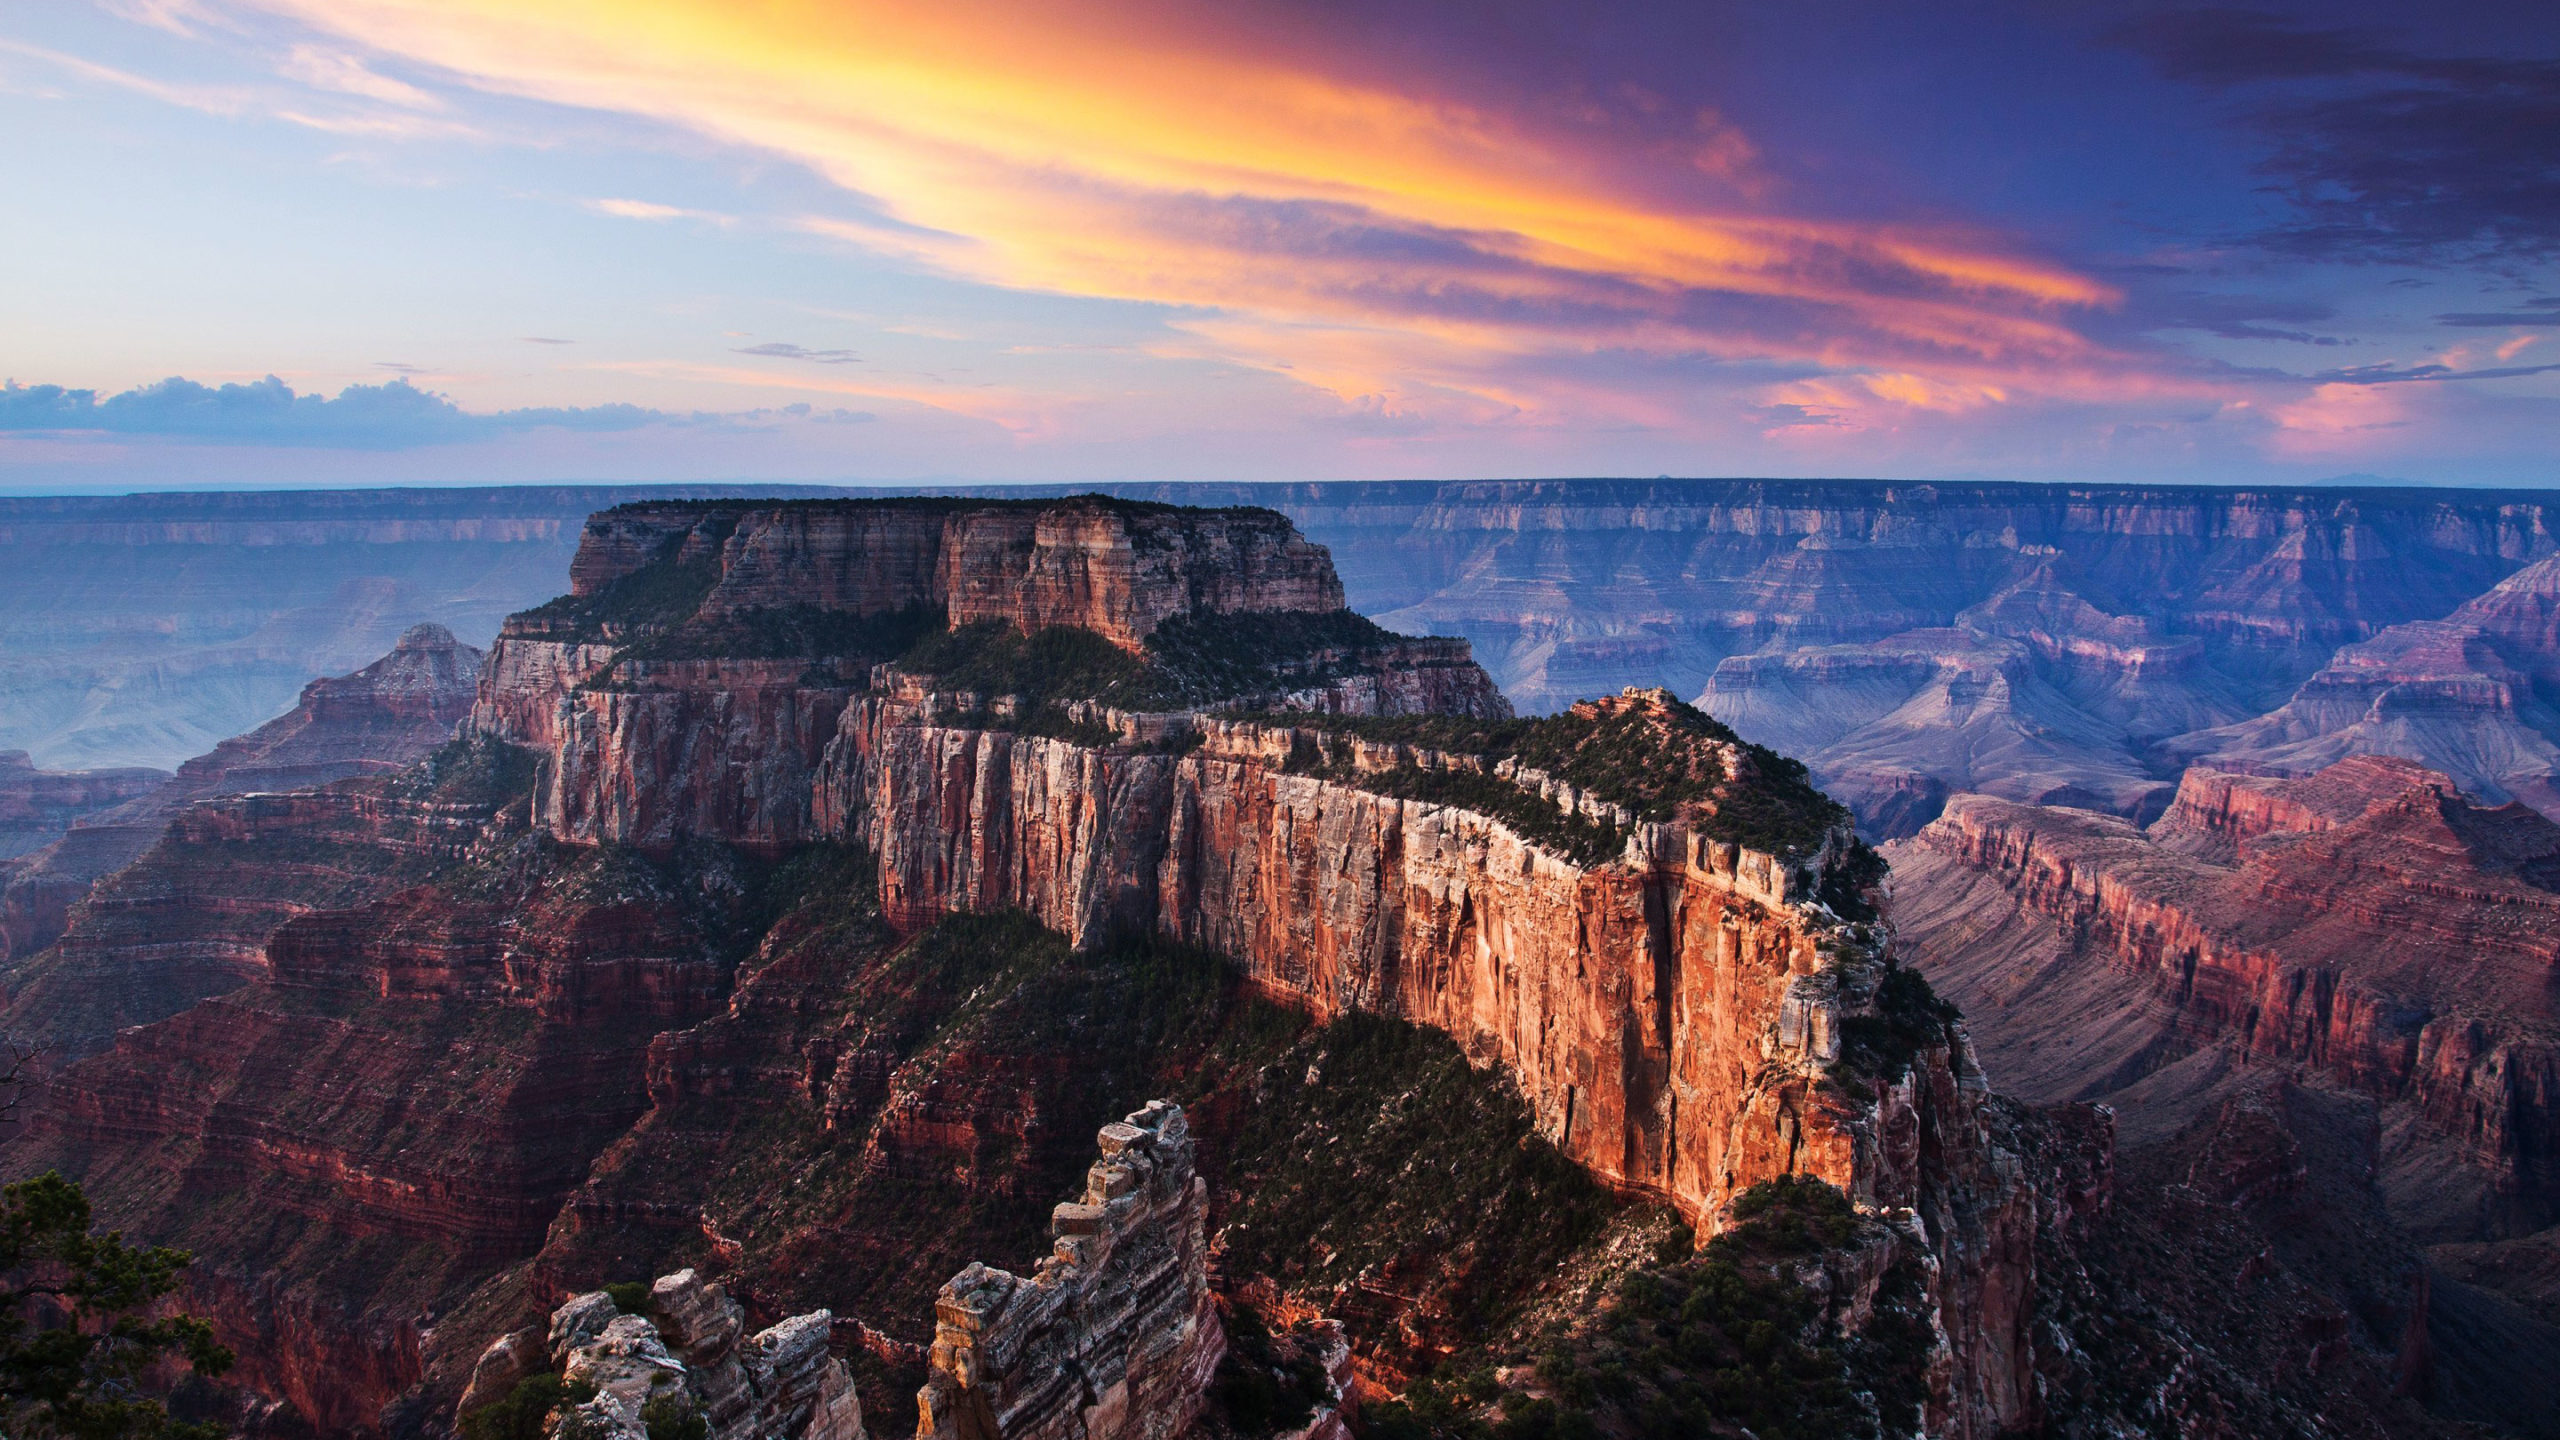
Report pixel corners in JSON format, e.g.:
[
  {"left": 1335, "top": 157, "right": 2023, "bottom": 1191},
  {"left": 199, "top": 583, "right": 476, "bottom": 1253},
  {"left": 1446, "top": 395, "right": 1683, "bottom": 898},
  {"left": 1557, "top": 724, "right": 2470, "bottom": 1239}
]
[{"left": 20, "top": 479, "right": 2560, "bottom": 840}]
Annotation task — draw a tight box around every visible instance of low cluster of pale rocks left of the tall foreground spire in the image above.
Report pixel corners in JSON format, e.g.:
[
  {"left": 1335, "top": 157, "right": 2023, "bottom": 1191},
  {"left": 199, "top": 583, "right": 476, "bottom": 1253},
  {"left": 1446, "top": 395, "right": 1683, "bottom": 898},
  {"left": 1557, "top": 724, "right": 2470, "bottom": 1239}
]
[{"left": 524, "top": 1271, "right": 865, "bottom": 1440}]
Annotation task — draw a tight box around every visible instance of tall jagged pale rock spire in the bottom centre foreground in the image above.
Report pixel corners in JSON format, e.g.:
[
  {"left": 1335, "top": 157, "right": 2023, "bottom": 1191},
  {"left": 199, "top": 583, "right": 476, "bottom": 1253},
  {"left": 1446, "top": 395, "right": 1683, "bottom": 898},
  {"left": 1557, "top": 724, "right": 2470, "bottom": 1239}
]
[{"left": 916, "top": 1099, "right": 1226, "bottom": 1440}]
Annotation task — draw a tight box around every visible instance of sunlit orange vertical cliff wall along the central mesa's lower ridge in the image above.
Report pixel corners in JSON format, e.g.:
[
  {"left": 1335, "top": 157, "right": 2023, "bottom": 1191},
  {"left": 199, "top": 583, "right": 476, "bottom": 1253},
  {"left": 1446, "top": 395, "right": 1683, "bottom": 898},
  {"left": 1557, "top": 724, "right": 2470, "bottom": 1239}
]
[{"left": 822, "top": 700, "right": 2068, "bottom": 1432}]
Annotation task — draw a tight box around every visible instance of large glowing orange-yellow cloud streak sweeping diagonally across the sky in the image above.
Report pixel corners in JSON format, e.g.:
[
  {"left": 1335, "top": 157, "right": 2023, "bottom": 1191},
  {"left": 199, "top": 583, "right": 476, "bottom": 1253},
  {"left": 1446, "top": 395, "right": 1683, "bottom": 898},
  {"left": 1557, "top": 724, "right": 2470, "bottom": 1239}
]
[{"left": 240, "top": 0, "right": 2115, "bottom": 405}]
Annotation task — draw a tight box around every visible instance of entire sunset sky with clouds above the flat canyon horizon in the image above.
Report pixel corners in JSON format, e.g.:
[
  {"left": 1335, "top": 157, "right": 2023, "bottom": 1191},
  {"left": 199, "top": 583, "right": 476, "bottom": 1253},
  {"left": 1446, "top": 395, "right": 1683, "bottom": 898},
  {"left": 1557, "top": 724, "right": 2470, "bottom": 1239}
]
[{"left": 0, "top": 0, "right": 2560, "bottom": 492}]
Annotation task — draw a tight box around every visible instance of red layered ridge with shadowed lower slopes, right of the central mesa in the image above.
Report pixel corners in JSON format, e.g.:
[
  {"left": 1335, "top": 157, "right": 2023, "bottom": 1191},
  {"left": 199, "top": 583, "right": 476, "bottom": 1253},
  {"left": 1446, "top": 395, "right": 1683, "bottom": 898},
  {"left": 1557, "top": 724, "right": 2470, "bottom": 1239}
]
[{"left": 1887, "top": 756, "right": 2560, "bottom": 1432}]
